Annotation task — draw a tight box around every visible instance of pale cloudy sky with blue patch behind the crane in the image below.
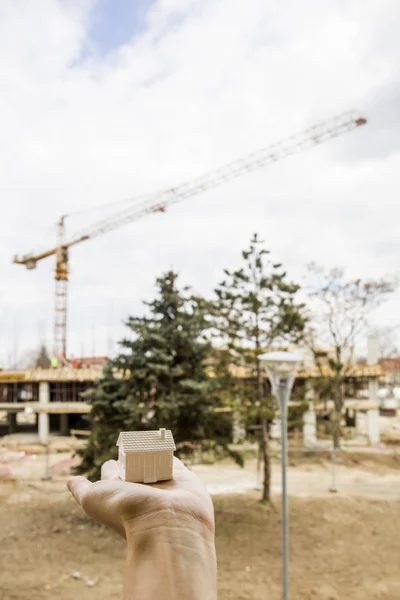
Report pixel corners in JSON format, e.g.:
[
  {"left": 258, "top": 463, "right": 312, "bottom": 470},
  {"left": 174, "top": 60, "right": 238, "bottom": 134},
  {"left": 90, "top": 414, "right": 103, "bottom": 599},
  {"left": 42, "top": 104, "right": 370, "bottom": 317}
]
[{"left": 0, "top": 0, "right": 400, "bottom": 363}]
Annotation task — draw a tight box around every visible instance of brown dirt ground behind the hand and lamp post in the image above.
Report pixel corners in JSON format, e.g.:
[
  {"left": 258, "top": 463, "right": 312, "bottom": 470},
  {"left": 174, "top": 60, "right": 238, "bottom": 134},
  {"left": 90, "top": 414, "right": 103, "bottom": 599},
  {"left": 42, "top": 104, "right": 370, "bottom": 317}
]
[{"left": 0, "top": 455, "right": 400, "bottom": 600}]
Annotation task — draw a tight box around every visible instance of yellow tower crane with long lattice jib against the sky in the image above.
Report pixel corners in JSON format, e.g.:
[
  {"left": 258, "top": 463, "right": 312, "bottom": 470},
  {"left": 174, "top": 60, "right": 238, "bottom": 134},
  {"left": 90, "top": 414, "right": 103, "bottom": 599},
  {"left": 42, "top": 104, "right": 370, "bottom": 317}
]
[{"left": 13, "top": 111, "right": 367, "bottom": 364}]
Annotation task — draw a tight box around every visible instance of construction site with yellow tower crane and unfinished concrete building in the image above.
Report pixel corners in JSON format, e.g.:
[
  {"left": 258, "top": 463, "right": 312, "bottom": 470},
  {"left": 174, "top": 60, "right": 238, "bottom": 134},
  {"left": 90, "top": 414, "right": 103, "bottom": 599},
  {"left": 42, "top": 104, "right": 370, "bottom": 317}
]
[{"left": 0, "top": 112, "right": 399, "bottom": 478}]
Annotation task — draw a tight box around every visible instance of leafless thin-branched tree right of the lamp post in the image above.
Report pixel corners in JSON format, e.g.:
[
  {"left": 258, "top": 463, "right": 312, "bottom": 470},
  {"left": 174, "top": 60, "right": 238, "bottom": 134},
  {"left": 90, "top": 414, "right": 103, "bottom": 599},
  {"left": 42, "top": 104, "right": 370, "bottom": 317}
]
[{"left": 308, "top": 263, "right": 395, "bottom": 448}]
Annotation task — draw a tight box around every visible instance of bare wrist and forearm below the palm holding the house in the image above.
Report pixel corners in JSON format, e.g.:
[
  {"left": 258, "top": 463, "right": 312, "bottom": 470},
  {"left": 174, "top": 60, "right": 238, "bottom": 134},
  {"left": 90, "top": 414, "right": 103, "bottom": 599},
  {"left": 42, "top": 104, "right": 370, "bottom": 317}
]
[{"left": 124, "top": 508, "right": 217, "bottom": 600}]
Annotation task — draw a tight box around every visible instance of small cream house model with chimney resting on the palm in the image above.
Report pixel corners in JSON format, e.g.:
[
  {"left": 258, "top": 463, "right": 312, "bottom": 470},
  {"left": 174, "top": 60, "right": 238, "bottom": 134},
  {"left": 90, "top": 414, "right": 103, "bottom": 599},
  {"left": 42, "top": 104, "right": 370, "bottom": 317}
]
[{"left": 117, "top": 429, "right": 176, "bottom": 483}]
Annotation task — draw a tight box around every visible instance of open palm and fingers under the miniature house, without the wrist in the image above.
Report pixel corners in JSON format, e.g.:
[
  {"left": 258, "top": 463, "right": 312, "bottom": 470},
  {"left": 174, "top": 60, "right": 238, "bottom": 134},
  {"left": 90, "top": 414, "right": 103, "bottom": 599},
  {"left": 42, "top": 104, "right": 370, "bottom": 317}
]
[{"left": 67, "top": 458, "right": 214, "bottom": 537}]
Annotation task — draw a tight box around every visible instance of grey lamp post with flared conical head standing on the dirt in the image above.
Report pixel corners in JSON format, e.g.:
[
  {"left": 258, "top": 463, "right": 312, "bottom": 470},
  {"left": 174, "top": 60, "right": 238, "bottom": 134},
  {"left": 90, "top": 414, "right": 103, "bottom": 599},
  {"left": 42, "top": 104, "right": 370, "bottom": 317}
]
[{"left": 259, "top": 352, "right": 301, "bottom": 600}]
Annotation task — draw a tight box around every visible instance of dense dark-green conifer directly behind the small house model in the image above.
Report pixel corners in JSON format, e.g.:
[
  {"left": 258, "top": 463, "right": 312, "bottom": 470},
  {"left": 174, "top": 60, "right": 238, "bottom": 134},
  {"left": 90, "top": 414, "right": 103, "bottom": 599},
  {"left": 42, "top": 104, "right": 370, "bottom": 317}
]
[{"left": 78, "top": 272, "right": 222, "bottom": 478}]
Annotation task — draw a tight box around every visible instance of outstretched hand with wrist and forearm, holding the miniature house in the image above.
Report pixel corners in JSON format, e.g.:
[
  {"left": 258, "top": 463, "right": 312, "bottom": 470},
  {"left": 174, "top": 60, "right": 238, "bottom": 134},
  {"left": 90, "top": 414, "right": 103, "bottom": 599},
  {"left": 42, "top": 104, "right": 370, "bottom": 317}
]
[{"left": 68, "top": 458, "right": 217, "bottom": 600}]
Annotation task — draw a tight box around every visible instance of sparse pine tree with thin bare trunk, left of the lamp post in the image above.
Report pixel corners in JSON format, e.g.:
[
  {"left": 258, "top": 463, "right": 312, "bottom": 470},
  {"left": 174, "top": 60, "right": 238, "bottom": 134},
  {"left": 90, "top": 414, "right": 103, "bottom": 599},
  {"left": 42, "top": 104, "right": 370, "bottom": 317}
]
[{"left": 215, "top": 234, "right": 305, "bottom": 500}]
